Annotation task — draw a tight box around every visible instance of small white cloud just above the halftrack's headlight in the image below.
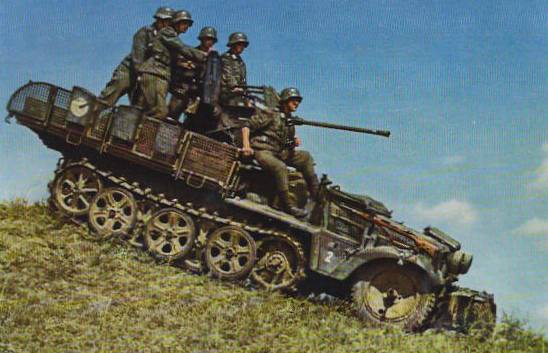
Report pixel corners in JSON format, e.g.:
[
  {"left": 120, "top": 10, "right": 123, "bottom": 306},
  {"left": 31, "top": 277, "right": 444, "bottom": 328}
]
[{"left": 411, "top": 199, "right": 478, "bottom": 226}]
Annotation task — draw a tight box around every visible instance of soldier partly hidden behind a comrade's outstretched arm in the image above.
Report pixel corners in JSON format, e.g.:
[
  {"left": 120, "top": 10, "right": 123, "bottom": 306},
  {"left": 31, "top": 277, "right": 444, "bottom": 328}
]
[{"left": 168, "top": 27, "right": 217, "bottom": 120}]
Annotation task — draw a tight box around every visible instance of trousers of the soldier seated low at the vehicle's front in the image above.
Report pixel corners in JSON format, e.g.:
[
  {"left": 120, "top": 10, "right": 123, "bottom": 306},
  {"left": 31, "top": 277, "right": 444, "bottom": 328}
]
[{"left": 255, "top": 150, "right": 319, "bottom": 198}]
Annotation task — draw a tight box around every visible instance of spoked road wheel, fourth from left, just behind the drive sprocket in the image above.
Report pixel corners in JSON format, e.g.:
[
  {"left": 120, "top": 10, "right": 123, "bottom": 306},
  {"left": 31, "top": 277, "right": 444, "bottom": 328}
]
[{"left": 205, "top": 226, "right": 257, "bottom": 280}]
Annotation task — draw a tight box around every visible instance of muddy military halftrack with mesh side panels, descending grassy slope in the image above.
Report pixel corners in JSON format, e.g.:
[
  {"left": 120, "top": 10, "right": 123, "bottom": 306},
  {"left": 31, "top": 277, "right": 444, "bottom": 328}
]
[{"left": 3, "top": 75, "right": 495, "bottom": 330}]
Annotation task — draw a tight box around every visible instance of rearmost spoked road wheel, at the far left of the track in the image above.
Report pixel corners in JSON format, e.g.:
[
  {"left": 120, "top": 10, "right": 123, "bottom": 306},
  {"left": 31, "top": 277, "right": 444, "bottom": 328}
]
[{"left": 51, "top": 166, "right": 103, "bottom": 217}]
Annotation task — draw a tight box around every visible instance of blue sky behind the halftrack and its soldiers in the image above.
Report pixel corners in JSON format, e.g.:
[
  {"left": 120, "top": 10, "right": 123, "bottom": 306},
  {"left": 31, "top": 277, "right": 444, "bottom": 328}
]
[{"left": 0, "top": 0, "right": 548, "bottom": 330}]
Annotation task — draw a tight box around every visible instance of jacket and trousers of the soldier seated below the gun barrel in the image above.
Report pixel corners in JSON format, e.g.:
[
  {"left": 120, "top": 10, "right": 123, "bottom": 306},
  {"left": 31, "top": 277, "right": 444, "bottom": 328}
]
[{"left": 246, "top": 112, "right": 319, "bottom": 205}]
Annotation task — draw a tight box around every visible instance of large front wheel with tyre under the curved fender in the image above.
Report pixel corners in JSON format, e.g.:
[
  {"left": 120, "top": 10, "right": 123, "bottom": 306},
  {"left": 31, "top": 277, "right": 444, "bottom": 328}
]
[{"left": 352, "top": 262, "right": 436, "bottom": 331}]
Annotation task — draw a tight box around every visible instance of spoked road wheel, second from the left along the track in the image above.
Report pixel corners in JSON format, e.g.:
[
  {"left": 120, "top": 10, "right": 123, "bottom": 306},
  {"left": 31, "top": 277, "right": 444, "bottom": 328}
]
[{"left": 88, "top": 187, "right": 137, "bottom": 238}]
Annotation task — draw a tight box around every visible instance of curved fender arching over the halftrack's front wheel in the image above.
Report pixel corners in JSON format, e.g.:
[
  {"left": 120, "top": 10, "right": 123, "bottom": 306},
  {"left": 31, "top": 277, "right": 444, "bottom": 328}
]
[{"left": 330, "top": 246, "right": 445, "bottom": 286}]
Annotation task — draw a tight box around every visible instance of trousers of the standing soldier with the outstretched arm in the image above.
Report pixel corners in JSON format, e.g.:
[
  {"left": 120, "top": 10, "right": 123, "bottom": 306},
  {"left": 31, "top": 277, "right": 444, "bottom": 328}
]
[{"left": 139, "top": 72, "right": 169, "bottom": 120}]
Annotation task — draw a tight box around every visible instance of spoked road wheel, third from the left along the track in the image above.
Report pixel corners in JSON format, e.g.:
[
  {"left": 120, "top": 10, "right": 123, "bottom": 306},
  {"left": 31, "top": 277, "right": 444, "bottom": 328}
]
[{"left": 144, "top": 208, "right": 196, "bottom": 261}]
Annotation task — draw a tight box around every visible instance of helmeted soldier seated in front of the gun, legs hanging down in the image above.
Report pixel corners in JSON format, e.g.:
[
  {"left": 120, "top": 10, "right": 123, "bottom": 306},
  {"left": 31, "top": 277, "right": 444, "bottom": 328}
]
[{"left": 242, "top": 88, "right": 319, "bottom": 218}]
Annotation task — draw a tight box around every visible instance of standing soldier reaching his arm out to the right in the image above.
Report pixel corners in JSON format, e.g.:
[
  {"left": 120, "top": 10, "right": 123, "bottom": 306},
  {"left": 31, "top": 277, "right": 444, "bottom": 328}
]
[{"left": 139, "top": 10, "right": 207, "bottom": 119}]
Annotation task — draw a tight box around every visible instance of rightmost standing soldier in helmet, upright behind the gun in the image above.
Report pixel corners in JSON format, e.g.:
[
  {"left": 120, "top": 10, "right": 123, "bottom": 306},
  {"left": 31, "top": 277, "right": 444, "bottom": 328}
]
[{"left": 220, "top": 32, "right": 249, "bottom": 106}]
